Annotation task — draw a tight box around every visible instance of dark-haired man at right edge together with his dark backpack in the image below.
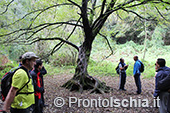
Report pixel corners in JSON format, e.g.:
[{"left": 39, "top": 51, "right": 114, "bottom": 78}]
[{"left": 153, "top": 58, "right": 170, "bottom": 113}]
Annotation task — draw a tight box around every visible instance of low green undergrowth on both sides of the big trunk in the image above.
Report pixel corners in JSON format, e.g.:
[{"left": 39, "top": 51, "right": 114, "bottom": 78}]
[{"left": 0, "top": 40, "right": 170, "bottom": 78}]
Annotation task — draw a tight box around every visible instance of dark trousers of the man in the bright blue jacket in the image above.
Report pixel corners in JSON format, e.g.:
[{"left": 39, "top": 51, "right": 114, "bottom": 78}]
[{"left": 134, "top": 74, "right": 142, "bottom": 94}]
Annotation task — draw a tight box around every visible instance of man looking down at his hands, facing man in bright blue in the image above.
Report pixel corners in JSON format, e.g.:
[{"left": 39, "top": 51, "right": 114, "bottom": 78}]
[{"left": 118, "top": 58, "right": 128, "bottom": 91}]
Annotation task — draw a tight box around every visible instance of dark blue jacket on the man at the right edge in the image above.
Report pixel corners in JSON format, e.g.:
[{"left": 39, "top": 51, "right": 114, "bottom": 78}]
[{"left": 153, "top": 66, "right": 170, "bottom": 97}]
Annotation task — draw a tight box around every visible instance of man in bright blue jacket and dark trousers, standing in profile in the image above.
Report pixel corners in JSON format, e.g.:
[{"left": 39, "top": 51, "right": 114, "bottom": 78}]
[{"left": 133, "top": 56, "right": 143, "bottom": 94}]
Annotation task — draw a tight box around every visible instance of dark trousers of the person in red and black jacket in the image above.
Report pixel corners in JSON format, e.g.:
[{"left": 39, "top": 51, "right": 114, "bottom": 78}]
[{"left": 32, "top": 96, "right": 43, "bottom": 113}]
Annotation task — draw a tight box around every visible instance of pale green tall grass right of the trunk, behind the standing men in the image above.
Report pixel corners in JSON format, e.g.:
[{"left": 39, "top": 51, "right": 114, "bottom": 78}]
[{"left": 88, "top": 41, "right": 170, "bottom": 78}]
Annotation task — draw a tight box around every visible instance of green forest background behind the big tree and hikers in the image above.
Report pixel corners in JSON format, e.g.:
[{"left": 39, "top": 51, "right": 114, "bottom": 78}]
[{"left": 0, "top": 0, "right": 170, "bottom": 78}]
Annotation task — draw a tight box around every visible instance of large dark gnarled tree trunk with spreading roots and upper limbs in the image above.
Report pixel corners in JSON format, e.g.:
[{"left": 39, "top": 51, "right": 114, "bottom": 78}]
[{"left": 63, "top": 0, "right": 115, "bottom": 93}]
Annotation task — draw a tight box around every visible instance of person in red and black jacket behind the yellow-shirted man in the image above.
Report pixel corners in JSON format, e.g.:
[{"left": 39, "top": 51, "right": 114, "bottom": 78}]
[{"left": 31, "top": 59, "right": 44, "bottom": 113}]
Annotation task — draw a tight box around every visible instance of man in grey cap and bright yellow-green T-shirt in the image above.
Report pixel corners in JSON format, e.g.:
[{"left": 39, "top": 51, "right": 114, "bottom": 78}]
[{"left": 3, "top": 52, "right": 38, "bottom": 113}]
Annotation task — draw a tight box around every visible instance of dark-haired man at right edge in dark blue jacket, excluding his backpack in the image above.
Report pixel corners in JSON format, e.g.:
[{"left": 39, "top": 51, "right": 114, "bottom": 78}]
[{"left": 153, "top": 58, "right": 170, "bottom": 113}]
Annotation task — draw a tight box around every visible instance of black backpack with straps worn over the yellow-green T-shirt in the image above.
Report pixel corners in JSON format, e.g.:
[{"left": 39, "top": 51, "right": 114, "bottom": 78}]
[{"left": 0, "top": 67, "right": 32, "bottom": 101}]
